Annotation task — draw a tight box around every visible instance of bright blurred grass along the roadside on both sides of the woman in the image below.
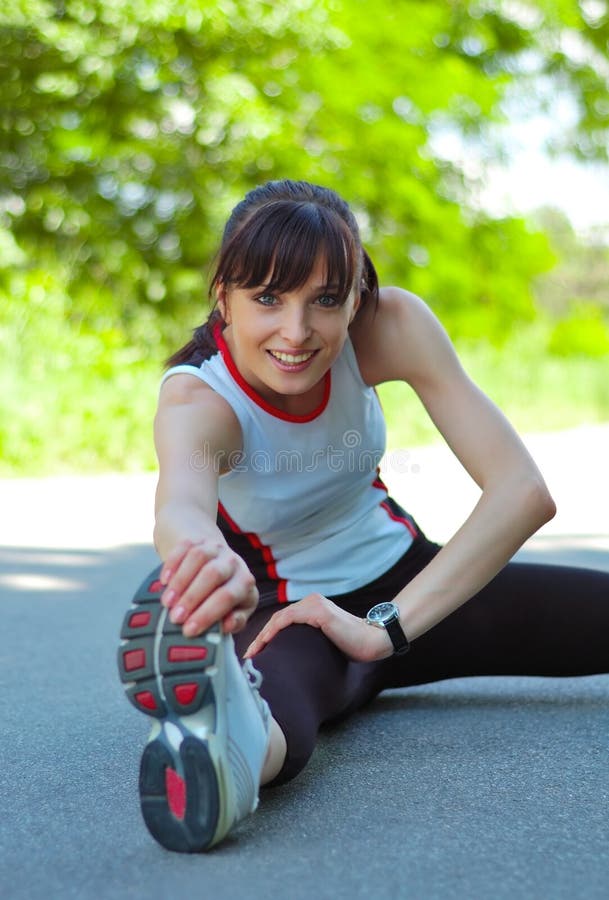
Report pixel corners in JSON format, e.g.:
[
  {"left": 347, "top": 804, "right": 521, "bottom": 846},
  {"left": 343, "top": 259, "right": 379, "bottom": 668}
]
[{"left": 0, "top": 321, "right": 609, "bottom": 477}]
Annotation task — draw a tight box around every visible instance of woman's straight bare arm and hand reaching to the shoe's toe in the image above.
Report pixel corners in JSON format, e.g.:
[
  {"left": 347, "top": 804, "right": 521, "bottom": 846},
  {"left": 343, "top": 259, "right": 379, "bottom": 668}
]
[{"left": 154, "top": 375, "right": 258, "bottom": 636}]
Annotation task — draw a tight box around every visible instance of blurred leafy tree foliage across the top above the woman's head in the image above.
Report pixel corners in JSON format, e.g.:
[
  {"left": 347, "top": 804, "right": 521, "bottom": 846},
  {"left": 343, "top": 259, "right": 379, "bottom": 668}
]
[{"left": 0, "top": 0, "right": 609, "bottom": 333}]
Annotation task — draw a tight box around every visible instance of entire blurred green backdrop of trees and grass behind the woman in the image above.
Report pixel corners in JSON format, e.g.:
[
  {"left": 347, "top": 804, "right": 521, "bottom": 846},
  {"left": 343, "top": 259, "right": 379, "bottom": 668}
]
[{"left": 0, "top": 0, "right": 609, "bottom": 475}]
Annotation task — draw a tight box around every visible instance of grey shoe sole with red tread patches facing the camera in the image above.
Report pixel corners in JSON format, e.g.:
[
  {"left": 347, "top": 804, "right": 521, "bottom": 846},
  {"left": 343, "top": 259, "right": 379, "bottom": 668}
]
[{"left": 118, "top": 566, "right": 226, "bottom": 853}]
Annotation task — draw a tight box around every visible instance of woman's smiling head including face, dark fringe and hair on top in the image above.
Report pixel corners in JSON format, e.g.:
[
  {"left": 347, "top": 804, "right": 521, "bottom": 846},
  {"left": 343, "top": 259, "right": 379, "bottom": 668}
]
[{"left": 212, "top": 200, "right": 363, "bottom": 415}]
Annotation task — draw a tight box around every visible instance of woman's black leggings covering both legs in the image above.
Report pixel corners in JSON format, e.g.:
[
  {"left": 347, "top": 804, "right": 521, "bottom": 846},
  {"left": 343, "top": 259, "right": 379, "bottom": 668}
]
[{"left": 235, "top": 537, "right": 609, "bottom": 784}]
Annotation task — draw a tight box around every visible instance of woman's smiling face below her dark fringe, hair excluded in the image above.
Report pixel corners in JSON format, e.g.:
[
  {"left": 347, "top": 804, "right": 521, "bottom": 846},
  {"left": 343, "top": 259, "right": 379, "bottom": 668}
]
[{"left": 218, "top": 255, "right": 359, "bottom": 413}]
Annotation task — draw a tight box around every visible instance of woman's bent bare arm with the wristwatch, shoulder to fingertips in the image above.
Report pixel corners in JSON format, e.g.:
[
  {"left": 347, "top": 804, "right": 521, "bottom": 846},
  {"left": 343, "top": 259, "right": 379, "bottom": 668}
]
[{"left": 245, "top": 288, "right": 555, "bottom": 659}]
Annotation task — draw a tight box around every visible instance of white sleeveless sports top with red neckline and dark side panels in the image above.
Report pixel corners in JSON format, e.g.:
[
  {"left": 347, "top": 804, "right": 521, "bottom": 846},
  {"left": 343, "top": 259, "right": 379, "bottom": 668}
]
[{"left": 163, "top": 328, "right": 417, "bottom": 603}]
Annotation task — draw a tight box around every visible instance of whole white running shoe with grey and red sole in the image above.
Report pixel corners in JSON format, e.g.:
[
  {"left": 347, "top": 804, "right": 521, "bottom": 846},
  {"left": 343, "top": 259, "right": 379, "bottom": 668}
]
[{"left": 118, "top": 566, "right": 270, "bottom": 853}]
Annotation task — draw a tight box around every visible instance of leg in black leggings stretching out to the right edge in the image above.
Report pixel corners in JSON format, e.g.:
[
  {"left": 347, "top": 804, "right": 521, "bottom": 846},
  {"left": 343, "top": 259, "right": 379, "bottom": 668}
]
[{"left": 383, "top": 562, "right": 609, "bottom": 687}]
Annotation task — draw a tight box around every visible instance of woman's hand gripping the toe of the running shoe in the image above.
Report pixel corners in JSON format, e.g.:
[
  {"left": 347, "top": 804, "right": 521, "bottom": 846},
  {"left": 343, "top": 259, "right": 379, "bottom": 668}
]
[{"left": 160, "top": 539, "right": 258, "bottom": 637}]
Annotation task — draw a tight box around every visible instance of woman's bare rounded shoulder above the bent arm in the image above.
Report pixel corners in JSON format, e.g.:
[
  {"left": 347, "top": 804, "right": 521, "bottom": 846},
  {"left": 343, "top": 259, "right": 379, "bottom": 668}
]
[{"left": 351, "top": 287, "right": 459, "bottom": 387}]
